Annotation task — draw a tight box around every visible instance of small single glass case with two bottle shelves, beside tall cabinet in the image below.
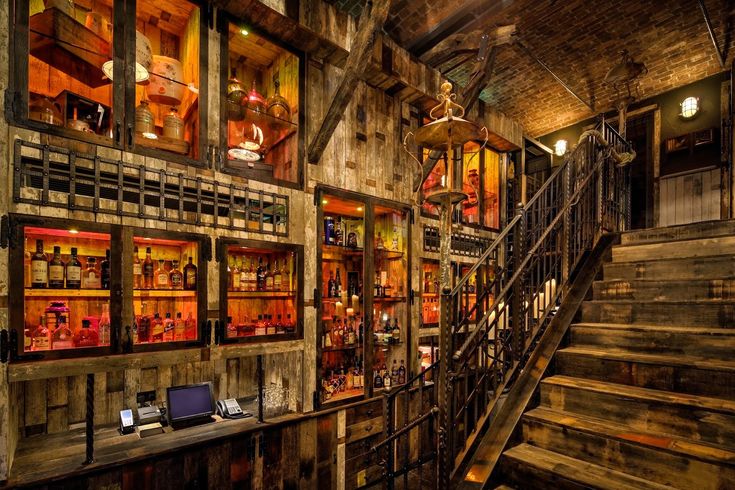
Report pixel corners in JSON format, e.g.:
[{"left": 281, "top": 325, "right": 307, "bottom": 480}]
[{"left": 225, "top": 245, "right": 299, "bottom": 339}]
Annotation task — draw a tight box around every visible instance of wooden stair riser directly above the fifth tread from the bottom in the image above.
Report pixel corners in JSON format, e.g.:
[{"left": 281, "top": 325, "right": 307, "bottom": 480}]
[{"left": 582, "top": 301, "right": 735, "bottom": 327}]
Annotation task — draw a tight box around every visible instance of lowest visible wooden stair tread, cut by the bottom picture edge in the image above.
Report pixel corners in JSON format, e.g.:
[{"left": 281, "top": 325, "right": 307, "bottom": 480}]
[{"left": 503, "top": 443, "right": 672, "bottom": 490}]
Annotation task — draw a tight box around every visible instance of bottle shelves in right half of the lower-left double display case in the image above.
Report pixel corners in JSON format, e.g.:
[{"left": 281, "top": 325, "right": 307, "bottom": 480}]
[{"left": 133, "top": 236, "right": 199, "bottom": 344}]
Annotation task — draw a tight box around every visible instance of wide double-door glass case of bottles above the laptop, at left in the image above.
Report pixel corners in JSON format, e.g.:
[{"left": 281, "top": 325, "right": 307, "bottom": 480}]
[{"left": 9, "top": 215, "right": 207, "bottom": 360}]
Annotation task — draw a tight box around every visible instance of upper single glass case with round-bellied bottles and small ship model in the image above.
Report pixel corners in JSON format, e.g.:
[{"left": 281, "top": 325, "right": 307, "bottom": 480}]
[{"left": 219, "top": 17, "right": 304, "bottom": 186}]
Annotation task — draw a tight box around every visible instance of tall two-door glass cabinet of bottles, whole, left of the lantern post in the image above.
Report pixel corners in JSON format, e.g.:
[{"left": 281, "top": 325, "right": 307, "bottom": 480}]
[{"left": 316, "top": 189, "right": 410, "bottom": 406}]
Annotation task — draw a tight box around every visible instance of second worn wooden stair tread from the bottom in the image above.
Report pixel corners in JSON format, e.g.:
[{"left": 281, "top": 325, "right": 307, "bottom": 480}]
[{"left": 523, "top": 407, "right": 735, "bottom": 466}]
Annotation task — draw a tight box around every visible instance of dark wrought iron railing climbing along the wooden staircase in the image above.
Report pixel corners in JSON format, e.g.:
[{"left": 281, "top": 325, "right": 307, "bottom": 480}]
[{"left": 378, "top": 121, "right": 635, "bottom": 488}]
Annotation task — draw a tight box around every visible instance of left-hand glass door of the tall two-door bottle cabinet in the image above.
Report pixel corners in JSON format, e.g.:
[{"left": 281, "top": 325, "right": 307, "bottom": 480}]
[{"left": 317, "top": 195, "right": 371, "bottom": 404}]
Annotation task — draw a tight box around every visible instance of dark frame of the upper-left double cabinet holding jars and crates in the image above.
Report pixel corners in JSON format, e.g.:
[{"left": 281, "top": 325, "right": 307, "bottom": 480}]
[{"left": 5, "top": 0, "right": 212, "bottom": 167}]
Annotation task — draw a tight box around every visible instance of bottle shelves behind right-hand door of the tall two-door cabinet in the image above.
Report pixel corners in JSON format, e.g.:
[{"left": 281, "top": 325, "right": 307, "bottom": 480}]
[{"left": 372, "top": 206, "right": 409, "bottom": 391}]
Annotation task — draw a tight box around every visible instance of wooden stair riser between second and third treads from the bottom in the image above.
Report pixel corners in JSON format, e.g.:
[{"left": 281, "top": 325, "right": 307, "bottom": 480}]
[{"left": 541, "top": 382, "right": 735, "bottom": 446}]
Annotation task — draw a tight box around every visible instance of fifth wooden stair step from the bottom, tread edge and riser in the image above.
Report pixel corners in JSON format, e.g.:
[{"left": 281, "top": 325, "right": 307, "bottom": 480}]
[{"left": 569, "top": 323, "right": 735, "bottom": 359}]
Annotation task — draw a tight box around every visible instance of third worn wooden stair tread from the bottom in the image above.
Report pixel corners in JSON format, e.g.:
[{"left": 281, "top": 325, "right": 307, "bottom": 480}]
[{"left": 541, "top": 374, "right": 735, "bottom": 414}]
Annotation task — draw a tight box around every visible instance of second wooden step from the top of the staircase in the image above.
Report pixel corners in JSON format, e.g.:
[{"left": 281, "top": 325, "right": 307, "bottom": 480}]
[{"left": 612, "top": 235, "right": 735, "bottom": 262}]
